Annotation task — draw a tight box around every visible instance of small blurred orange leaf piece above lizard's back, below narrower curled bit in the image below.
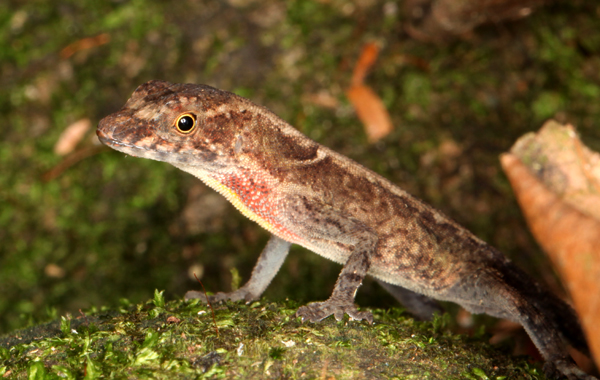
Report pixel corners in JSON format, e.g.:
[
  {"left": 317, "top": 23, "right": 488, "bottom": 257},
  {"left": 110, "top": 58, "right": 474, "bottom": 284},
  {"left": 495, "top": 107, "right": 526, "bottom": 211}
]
[{"left": 346, "top": 85, "right": 392, "bottom": 143}]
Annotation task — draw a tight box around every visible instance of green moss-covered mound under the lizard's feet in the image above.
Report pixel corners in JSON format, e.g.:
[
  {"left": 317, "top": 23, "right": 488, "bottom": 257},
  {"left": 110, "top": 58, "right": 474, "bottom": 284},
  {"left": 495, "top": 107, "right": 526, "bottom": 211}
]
[{"left": 0, "top": 300, "right": 544, "bottom": 379}]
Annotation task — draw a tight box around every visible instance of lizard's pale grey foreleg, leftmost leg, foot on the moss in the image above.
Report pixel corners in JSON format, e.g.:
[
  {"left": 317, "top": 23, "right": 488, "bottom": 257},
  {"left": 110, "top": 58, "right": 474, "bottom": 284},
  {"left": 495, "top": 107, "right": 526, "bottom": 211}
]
[{"left": 185, "top": 235, "right": 291, "bottom": 302}]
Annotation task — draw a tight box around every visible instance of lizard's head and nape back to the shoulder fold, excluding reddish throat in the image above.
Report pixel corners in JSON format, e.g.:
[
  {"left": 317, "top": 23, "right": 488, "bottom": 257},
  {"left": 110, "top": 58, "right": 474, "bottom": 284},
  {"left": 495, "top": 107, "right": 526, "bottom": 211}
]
[{"left": 96, "top": 80, "right": 319, "bottom": 178}]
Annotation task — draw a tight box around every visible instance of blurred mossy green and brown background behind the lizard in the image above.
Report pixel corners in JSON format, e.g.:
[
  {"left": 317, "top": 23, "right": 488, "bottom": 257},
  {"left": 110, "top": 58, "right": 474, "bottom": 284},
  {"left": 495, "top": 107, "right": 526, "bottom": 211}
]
[{"left": 0, "top": 0, "right": 600, "bottom": 340}]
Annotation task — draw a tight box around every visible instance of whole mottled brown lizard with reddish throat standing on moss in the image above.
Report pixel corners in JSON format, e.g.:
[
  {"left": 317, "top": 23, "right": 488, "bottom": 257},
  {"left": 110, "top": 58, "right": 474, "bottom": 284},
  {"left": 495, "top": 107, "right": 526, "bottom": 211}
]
[{"left": 97, "top": 81, "right": 593, "bottom": 380}]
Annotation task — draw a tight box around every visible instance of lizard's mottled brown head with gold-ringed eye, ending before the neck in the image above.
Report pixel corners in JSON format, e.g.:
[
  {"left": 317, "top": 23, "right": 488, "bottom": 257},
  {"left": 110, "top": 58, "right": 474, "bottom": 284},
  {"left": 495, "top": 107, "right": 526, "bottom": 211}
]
[{"left": 96, "top": 80, "right": 258, "bottom": 168}]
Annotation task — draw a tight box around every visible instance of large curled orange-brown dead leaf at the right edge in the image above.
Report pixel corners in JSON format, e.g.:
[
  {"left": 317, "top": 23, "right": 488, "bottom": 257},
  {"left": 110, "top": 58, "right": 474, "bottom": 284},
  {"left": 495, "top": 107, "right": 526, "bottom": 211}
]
[{"left": 501, "top": 121, "right": 600, "bottom": 364}]
